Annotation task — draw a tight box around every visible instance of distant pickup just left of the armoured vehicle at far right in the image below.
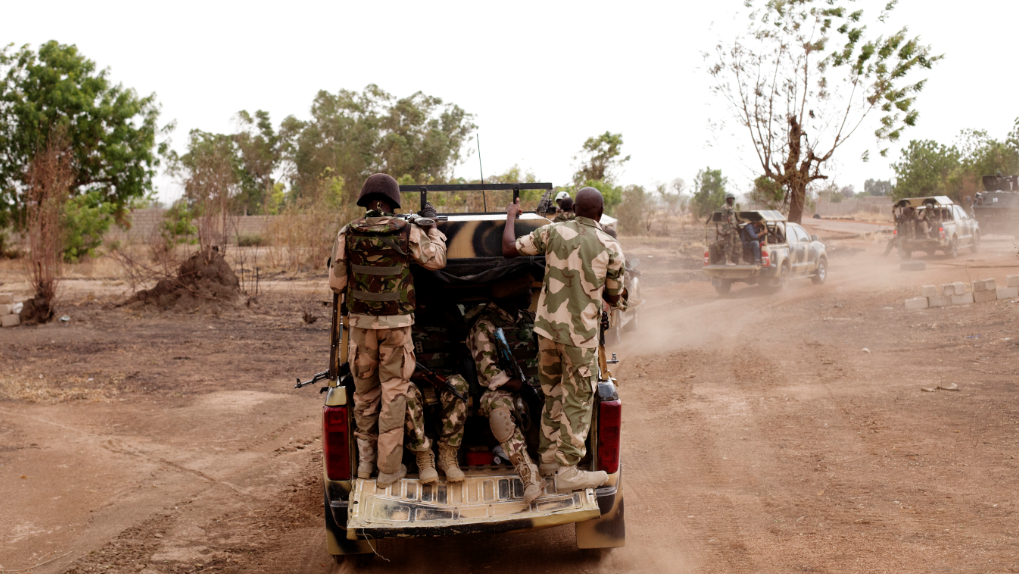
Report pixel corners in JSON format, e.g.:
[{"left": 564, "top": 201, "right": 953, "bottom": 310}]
[{"left": 892, "top": 196, "right": 980, "bottom": 259}]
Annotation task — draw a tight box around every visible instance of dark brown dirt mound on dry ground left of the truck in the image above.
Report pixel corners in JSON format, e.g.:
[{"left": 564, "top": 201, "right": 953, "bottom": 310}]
[{"left": 123, "top": 247, "right": 240, "bottom": 310}]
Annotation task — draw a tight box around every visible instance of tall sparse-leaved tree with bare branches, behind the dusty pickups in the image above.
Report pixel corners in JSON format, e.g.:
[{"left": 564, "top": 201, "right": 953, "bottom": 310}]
[{"left": 709, "top": 0, "right": 942, "bottom": 222}]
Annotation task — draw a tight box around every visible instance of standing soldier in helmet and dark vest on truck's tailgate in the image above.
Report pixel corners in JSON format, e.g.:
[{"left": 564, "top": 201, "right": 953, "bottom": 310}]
[{"left": 329, "top": 173, "right": 446, "bottom": 486}]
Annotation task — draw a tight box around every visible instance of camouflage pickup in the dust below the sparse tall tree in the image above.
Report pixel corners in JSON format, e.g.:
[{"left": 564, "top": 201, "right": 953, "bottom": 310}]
[{"left": 704, "top": 210, "right": 827, "bottom": 295}]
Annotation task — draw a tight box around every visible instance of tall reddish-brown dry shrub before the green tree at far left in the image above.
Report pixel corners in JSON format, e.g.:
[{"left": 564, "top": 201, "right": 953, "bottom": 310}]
[{"left": 22, "top": 132, "right": 74, "bottom": 322}]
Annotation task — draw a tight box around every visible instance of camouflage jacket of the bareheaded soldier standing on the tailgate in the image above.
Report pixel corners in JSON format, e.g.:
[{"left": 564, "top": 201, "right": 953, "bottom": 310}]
[{"left": 517, "top": 217, "right": 625, "bottom": 348}]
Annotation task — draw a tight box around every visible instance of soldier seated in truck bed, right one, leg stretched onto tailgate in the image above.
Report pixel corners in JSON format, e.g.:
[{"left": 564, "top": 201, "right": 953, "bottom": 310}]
[{"left": 467, "top": 289, "right": 545, "bottom": 505}]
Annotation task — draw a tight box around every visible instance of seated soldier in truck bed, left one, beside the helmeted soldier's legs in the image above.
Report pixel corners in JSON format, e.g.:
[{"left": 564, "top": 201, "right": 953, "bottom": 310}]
[{"left": 405, "top": 305, "right": 468, "bottom": 484}]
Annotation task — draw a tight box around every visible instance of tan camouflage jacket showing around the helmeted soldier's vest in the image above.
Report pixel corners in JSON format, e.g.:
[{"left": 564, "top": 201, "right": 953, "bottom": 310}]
[{"left": 329, "top": 215, "right": 445, "bottom": 329}]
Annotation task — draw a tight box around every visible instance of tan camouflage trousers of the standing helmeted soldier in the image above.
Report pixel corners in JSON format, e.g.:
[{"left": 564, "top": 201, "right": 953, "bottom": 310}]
[{"left": 346, "top": 327, "right": 414, "bottom": 473}]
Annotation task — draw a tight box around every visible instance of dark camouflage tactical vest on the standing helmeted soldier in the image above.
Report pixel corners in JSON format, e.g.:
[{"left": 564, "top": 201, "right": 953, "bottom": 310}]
[{"left": 345, "top": 218, "right": 416, "bottom": 316}]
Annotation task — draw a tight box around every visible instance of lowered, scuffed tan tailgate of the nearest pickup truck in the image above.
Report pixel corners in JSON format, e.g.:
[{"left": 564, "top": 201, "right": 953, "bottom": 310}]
[{"left": 346, "top": 473, "right": 601, "bottom": 540}]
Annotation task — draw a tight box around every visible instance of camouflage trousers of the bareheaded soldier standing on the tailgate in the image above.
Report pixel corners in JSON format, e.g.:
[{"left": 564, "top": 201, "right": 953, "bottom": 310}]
[{"left": 538, "top": 334, "right": 598, "bottom": 466}]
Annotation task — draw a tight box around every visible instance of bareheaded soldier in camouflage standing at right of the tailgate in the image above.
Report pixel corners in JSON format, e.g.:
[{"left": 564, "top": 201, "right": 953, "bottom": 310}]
[{"left": 502, "top": 188, "right": 625, "bottom": 492}]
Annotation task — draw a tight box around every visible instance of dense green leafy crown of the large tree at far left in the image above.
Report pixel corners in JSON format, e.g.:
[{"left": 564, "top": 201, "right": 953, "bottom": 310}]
[{"left": 0, "top": 41, "right": 165, "bottom": 224}]
